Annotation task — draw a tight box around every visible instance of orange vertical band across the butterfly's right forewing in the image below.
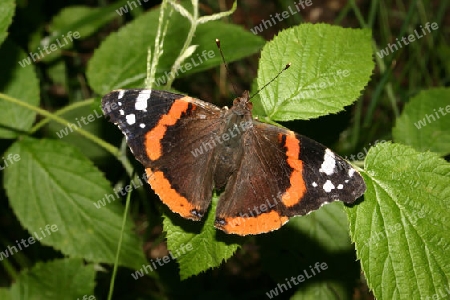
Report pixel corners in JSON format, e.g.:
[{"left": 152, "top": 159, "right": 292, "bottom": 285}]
[{"left": 281, "top": 131, "right": 306, "bottom": 207}]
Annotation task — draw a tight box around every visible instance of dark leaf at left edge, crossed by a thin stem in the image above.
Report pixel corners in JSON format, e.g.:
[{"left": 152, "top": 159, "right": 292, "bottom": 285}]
[{"left": 0, "top": 41, "right": 39, "bottom": 139}]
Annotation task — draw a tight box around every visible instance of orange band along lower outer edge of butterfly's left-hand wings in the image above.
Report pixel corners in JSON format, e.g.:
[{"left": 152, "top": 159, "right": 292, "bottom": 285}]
[{"left": 145, "top": 168, "right": 196, "bottom": 219}]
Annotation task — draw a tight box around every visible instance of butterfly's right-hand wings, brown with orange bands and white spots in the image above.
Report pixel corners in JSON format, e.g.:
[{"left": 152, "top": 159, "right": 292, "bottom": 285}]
[{"left": 216, "top": 121, "right": 365, "bottom": 235}]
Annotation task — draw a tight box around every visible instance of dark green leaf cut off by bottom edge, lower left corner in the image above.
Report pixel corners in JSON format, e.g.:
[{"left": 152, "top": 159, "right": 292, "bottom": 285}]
[{"left": 8, "top": 258, "right": 95, "bottom": 300}]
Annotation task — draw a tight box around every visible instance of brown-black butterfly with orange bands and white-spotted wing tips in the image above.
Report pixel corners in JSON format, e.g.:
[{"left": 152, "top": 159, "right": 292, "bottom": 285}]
[{"left": 102, "top": 89, "right": 366, "bottom": 235}]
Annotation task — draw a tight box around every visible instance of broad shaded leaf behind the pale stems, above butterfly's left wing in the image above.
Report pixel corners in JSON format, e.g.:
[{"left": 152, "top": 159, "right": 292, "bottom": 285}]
[{"left": 87, "top": 8, "right": 264, "bottom": 94}]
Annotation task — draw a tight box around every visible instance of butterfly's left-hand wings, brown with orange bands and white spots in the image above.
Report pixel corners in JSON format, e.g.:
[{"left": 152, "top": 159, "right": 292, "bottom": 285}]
[{"left": 102, "top": 89, "right": 227, "bottom": 220}]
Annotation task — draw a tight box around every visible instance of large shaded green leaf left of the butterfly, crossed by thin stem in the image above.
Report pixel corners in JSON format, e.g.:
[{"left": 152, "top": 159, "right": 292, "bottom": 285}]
[{"left": 4, "top": 138, "right": 145, "bottom": 268}]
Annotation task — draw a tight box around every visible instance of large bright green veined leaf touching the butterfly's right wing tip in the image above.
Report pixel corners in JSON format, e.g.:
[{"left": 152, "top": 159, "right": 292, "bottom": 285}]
[{"left": 347, "top": 143, "right": 450, "bottom": 299}]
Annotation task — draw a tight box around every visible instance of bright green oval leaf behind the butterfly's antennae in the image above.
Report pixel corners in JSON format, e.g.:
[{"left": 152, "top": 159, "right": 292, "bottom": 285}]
[{"left": 256, "top": 24, "right": 374, "bottom": 121}]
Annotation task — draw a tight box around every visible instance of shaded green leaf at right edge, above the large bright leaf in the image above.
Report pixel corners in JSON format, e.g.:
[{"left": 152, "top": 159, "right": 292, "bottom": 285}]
[{"left": 392, "top": 88, "right": 450, "bottom": 156}]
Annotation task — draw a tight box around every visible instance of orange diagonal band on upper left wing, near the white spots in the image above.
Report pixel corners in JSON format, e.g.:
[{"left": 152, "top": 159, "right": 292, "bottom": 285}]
[{"left": 145, "top": 97, "right": 195, "bottom": 160}]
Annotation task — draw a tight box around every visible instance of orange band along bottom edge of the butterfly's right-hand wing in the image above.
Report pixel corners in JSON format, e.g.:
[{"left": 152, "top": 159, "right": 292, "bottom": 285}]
[{"left": 220, "top": 210, "right": 289, "bottom": 235}]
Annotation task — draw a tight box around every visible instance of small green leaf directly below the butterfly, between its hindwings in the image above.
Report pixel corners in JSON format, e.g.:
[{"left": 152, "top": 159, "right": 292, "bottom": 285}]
[{"left": 163, "top": 197, "right": 240, "bottom": 280}]
